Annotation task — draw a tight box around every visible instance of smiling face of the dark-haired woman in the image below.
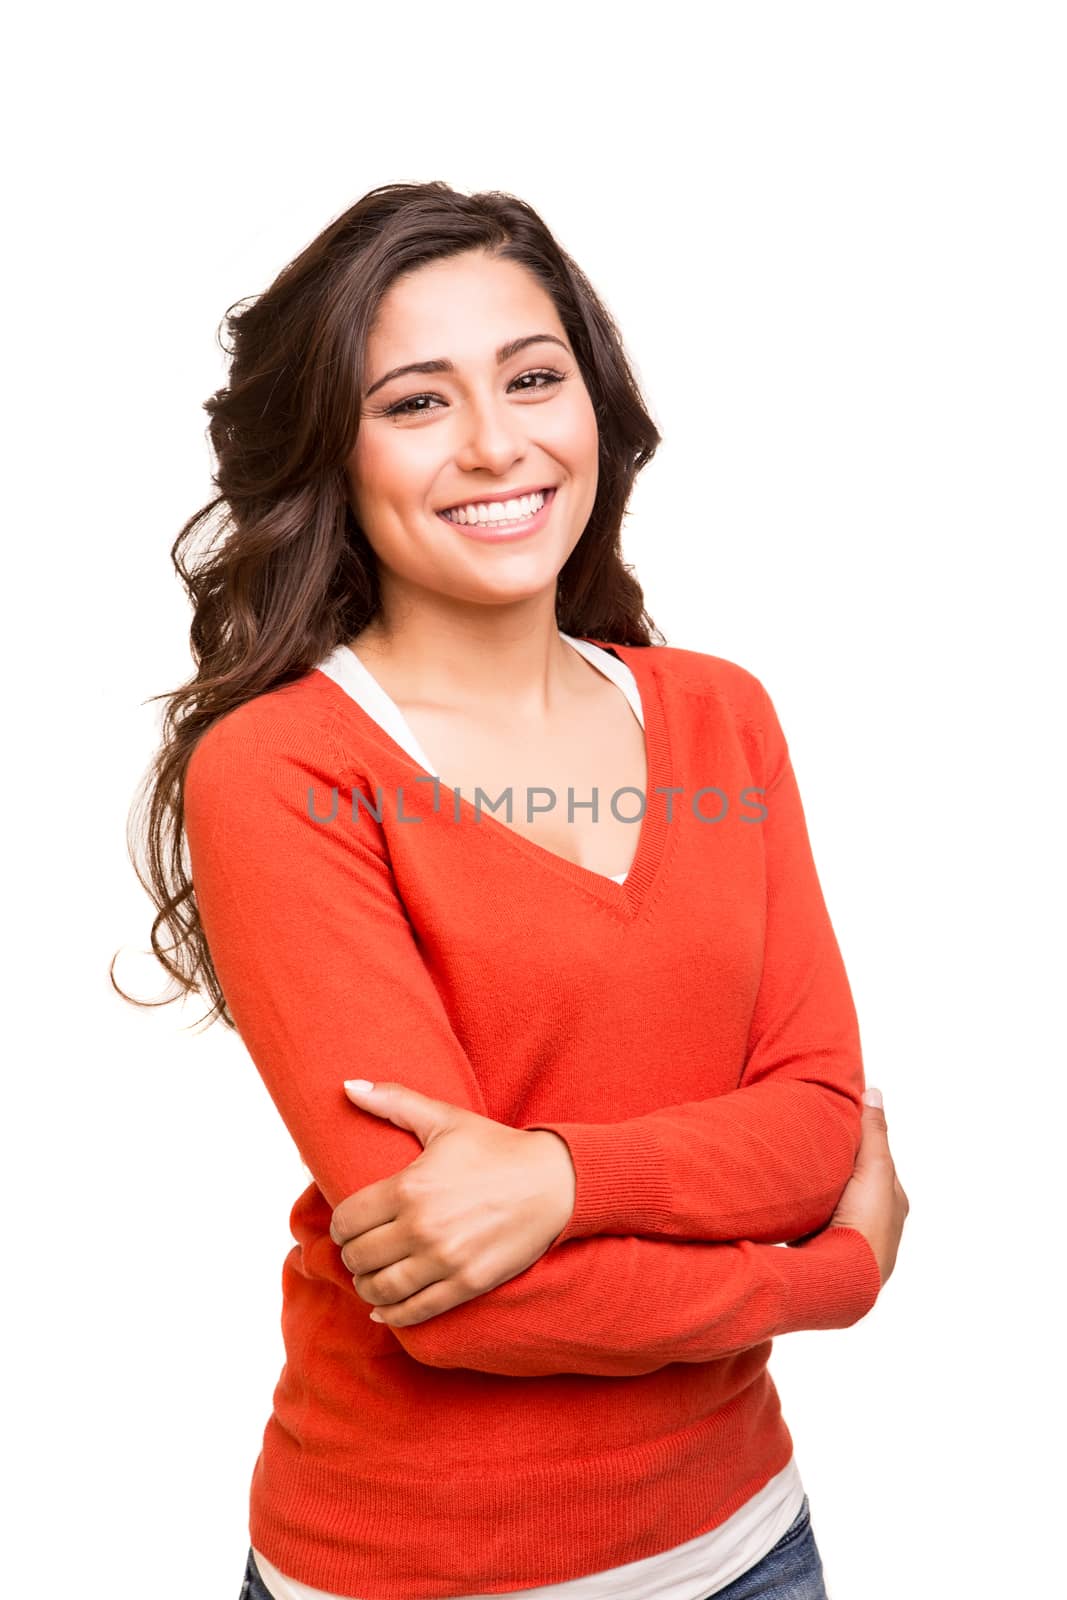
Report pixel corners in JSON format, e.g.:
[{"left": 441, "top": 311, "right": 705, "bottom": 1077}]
[{"left": 346, "top": 250, "right": 598, "bottom": 614}]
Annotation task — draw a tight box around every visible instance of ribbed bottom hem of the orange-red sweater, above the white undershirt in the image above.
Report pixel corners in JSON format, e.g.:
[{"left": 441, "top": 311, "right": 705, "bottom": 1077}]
[{"left": 250, "top": 1369, "right": 793, "bottom": 1600}]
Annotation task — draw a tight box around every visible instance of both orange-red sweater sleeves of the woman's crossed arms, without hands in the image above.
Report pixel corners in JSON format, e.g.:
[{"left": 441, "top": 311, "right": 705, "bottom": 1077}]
[{"left": 184, "top": 702, "right": 880, "bottom": 1376}]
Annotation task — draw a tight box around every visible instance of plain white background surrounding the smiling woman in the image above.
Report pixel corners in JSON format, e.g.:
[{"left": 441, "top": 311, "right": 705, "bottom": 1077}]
[{"left": 0, "top": 0, "right": 1067, "bottom": 1600}]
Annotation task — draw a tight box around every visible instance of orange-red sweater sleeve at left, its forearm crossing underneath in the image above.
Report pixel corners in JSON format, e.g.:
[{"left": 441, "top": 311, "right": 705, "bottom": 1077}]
[{"left": 184, "top": 702, "right": 880, "bottom": 1376}]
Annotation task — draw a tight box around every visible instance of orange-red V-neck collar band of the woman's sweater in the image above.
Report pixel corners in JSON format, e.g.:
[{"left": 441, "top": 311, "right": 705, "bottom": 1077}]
[{"left": 314, "top": 634, "right": 672, "bottom": 920}]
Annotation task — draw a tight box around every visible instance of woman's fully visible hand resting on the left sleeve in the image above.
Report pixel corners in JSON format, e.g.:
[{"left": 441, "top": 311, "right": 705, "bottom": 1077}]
[{"left": 330, "top": 1083, "right": 576, "bottom": 1328}]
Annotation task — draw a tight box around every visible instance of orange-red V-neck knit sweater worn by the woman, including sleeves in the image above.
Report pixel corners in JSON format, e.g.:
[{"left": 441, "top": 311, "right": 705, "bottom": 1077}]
[{"left": 186, "top": 640, "right": 880, "bottom": 1600}]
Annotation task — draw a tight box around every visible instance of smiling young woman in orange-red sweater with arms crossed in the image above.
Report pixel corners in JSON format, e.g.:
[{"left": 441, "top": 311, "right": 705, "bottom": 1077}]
[{"left": 123, "top": 184, "right": 907, "bottom": 1600}]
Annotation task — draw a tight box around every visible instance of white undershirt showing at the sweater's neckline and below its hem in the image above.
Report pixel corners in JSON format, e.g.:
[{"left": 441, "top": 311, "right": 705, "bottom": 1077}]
[{"left": 253, "top": 632, "right": 805, "bottom": 1600}]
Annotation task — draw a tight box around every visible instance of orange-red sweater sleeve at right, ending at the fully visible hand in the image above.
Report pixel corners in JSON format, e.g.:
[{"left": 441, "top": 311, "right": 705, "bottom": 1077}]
[{"left": 525, "top": 680, "right": 864, "bottom": 1248}]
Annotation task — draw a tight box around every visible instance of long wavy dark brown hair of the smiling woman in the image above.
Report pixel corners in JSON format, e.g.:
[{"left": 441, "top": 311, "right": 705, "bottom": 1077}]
[{"left": 110, "top": 182, "right": 664, "bottom": 1027}]
